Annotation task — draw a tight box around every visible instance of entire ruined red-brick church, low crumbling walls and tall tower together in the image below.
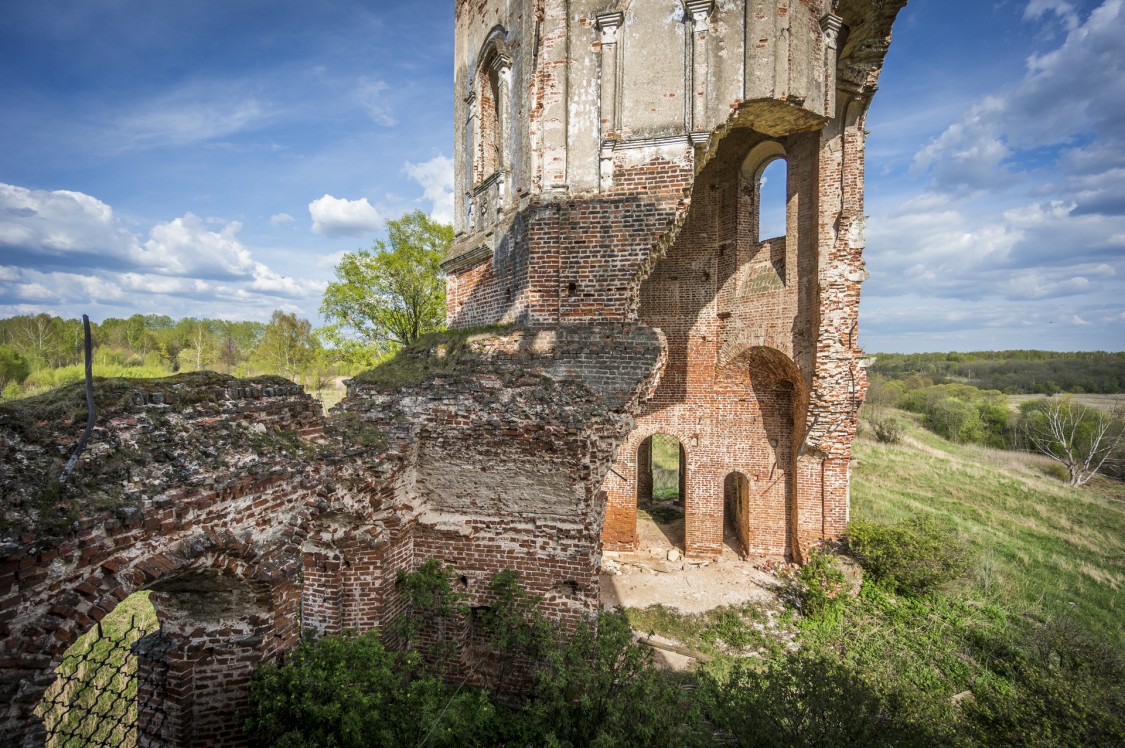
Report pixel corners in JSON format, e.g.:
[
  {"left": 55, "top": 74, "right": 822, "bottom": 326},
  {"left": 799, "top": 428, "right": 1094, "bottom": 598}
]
[{"left": 0, "top": 0, "right": 905, "bottom": 746}]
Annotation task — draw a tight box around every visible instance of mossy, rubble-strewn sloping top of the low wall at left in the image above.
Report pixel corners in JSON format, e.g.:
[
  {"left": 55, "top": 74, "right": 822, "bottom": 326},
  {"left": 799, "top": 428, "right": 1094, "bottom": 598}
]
[{"left": 0, "top": 371, "right": 302, "bottom": 539}]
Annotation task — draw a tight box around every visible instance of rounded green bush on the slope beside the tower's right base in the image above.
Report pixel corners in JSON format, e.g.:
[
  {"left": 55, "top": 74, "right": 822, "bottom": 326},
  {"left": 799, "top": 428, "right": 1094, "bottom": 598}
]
[{"left": 847, "top": 516, "right": 969, "bottom": 594}]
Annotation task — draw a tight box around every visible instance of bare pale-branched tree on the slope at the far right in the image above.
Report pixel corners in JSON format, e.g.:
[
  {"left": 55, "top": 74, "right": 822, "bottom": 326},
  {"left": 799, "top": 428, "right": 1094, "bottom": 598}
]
[{"left": 1023, "top": 397, "right": 1125, "bottom": 486}]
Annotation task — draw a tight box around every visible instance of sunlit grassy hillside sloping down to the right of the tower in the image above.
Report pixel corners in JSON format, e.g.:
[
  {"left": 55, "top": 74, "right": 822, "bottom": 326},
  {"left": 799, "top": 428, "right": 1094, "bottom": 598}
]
[{"left": 852, "top": 411, "right": 1125, "bottom": 645}]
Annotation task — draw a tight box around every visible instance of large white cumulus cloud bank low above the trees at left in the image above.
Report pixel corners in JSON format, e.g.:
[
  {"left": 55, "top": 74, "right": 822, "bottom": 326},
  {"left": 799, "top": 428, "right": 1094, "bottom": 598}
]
[{"left": 0, "top": 183, "right": 324, "bottom": 316}]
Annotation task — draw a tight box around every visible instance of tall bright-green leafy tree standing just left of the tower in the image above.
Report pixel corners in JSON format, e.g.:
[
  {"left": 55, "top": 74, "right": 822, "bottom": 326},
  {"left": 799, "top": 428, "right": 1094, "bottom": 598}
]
[{"left": 321, "top": 210, "right": 453, "bottom": 350}]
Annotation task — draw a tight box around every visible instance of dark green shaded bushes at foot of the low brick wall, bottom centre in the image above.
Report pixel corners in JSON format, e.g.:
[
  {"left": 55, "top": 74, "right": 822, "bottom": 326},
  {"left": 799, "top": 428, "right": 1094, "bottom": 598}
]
[{"left": 245, "top": 569, "right": 710, "bottom": 748}]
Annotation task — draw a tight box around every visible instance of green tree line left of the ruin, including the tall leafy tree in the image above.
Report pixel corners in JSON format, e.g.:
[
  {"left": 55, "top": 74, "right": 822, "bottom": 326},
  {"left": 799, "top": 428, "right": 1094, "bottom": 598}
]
[{"left": 0, "top": 211, "right": 453, "bottom": 399}]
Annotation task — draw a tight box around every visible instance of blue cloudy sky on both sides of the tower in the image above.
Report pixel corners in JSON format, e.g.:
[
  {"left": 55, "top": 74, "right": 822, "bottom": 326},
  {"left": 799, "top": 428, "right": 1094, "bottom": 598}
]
[{"left": 0, "top": 0, "right": 1125, "bottom": 351}]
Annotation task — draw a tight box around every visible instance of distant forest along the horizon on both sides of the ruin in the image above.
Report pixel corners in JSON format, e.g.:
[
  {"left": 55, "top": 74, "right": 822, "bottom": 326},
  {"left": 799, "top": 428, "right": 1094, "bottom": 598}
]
[{"left": 0, "top": 312, "right": 1125, "bottom": 398}]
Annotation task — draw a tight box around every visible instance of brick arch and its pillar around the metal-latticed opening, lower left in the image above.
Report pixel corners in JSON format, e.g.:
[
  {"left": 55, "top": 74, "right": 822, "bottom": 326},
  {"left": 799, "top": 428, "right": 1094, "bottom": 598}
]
[{"left": 0, "top": 526, "right": 299, "bottom": 746}]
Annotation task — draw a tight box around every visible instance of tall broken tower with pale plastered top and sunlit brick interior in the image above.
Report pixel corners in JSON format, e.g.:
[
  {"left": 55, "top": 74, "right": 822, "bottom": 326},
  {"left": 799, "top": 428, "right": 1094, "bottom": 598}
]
[{"left": 443, "top": 0, "right": 906, "bottom": 560}]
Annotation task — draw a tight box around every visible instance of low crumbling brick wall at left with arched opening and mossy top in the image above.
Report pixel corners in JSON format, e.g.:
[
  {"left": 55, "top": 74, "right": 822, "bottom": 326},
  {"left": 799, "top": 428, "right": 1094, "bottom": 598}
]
[{"left": 0, "top": 375, "right": 323, "bottom": 745}]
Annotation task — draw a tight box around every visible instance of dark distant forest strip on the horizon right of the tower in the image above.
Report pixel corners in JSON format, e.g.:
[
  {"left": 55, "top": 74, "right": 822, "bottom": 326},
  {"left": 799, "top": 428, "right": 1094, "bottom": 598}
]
[{"left": 867, "top": 351, "right": 1125, "bottom": 395}]
